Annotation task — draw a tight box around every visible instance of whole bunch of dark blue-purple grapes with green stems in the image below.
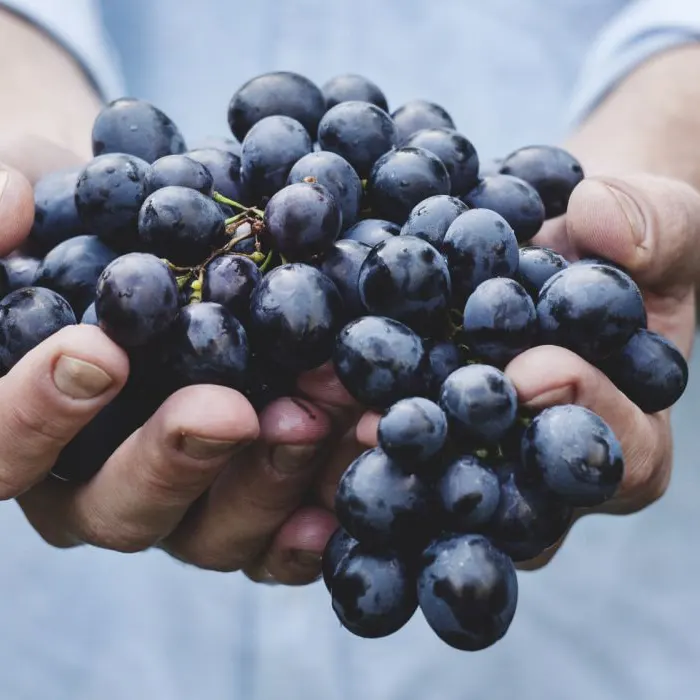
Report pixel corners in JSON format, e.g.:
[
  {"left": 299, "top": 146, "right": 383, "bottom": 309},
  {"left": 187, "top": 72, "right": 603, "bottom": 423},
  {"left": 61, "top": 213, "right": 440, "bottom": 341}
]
[{"left": 0, "top": 72, "right": 688, "bottom": 650}]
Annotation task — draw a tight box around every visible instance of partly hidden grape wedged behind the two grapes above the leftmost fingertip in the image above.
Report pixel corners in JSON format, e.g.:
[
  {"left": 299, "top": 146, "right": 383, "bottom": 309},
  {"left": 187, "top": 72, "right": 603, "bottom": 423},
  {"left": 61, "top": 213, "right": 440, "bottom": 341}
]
[{"left": 34, "top": 236, "right": 117, "bottom": 317}]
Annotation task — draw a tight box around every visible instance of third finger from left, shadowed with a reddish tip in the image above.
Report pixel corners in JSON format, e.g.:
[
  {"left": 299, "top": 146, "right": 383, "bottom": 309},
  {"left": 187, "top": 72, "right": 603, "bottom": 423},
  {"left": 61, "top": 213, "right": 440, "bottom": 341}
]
[{"left": 165, "top": 399, "right": 331, "bottom": 571}]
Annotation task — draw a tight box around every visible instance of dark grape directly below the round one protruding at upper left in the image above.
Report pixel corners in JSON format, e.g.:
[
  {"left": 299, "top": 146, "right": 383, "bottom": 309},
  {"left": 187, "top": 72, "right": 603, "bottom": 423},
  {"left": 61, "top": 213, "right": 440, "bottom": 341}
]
[{"left": 75, "top": 153, "right": 150, "bottom": 252}]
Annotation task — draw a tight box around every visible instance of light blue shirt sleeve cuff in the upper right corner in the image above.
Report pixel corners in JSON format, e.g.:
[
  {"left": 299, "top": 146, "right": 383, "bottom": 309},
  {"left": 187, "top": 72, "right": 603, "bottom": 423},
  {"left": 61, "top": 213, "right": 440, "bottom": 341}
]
[{"left": 569, "top": 0, "right": 700, "bottom": 126}]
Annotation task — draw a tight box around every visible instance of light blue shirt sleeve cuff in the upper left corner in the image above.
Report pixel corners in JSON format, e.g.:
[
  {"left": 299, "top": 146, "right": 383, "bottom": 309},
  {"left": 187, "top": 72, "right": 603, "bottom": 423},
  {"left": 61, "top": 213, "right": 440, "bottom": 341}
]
[{"left": 0, "top": 0, "right": 125, "bottom": 101}]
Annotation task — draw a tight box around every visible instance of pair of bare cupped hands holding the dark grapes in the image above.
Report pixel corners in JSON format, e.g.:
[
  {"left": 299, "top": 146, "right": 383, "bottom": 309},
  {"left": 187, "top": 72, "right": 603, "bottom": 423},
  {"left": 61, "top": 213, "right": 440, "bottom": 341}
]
[{"left": 0, "top": 141, "right": 700, "bottom": 585}]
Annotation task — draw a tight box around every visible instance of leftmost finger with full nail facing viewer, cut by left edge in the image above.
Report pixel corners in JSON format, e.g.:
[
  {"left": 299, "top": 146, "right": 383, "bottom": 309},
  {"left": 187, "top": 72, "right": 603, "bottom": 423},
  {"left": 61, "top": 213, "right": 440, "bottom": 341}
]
[{"left": 0, "top": 326, "right": 129, "bottom": 499}]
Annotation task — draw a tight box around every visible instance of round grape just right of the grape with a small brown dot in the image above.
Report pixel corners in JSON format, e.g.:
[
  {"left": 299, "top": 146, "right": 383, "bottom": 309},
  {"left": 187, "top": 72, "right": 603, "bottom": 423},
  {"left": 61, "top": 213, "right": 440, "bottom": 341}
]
[{"left": 367, "top": 148, "right": 450, "bottom": 225}]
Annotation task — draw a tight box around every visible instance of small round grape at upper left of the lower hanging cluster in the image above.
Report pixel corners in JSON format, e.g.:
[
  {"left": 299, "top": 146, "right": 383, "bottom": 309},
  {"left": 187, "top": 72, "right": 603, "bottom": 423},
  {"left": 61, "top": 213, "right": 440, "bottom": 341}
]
[{"left": 377, "top": 397, "right": 447, "bottom": 466}]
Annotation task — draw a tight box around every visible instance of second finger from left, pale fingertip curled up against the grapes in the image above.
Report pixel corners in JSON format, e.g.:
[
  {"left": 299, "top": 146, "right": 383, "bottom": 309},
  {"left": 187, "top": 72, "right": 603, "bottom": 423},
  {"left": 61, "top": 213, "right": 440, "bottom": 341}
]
[{"left": 23, "top": 386, "right": 259, "bottom": 552}]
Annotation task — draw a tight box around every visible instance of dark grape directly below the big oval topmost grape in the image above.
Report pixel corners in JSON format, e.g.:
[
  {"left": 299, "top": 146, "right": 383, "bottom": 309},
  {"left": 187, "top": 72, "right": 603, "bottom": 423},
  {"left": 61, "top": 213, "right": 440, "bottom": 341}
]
[{"left": 241, "top": 116, "right": 312, "bottom": 199}]
